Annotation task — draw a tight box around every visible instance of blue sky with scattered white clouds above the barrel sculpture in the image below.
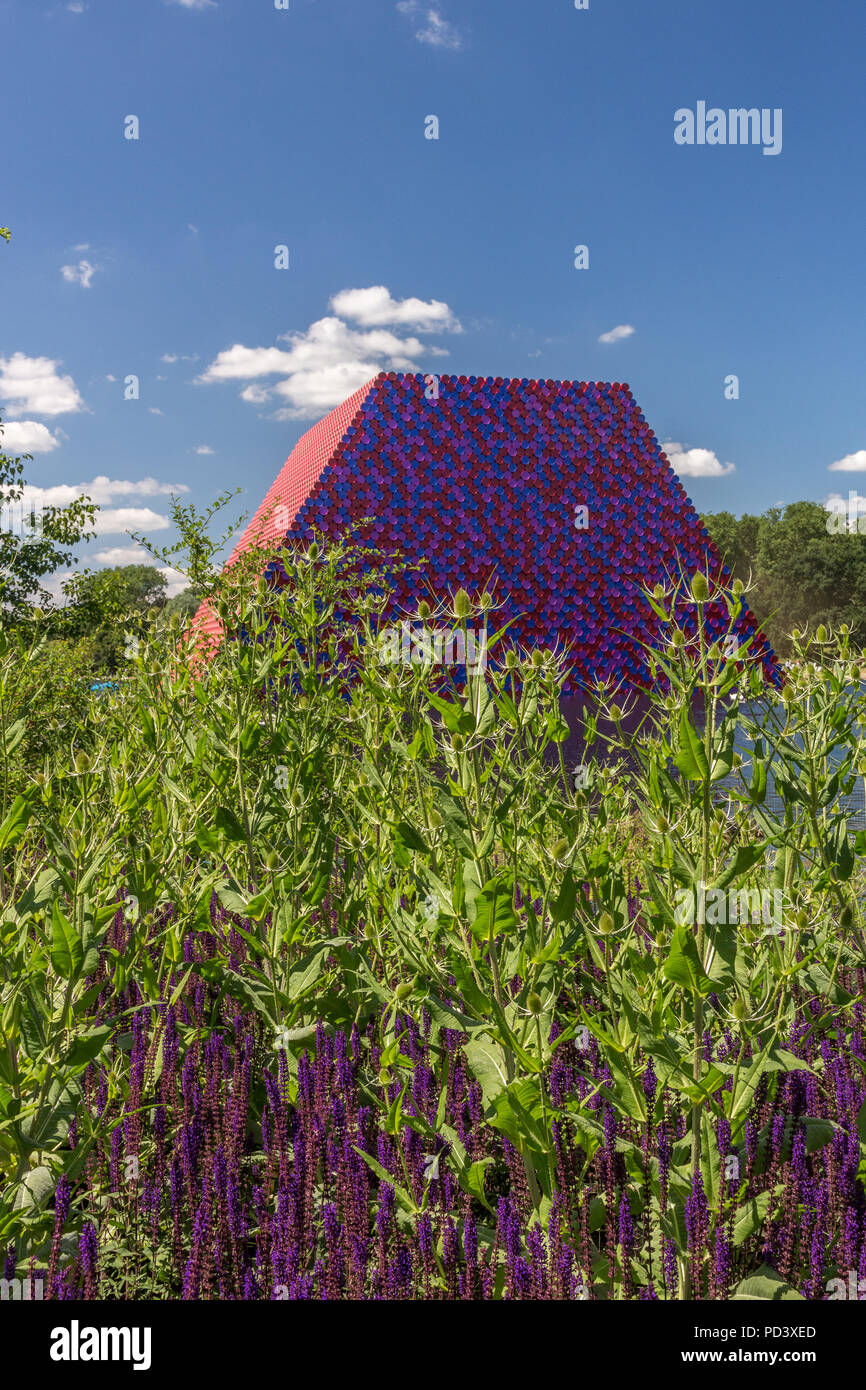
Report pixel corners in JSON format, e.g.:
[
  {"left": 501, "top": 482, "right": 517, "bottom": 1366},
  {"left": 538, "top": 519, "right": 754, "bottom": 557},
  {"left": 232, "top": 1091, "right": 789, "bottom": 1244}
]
[{"left": 0, "top": 0, "right": 866, "bottom": 592}]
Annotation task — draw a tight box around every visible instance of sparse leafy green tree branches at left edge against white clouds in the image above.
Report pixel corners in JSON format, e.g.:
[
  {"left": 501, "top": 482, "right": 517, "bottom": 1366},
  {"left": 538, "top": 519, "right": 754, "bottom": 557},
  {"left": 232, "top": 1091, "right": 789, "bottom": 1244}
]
[{"left": 0, "top": 421, "right": 97, "bottom": 623}]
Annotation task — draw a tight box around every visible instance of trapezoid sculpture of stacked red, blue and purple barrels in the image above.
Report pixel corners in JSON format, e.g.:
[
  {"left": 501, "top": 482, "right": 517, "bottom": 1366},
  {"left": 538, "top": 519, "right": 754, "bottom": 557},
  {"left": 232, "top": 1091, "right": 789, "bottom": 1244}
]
[{"left": 196, "top": 373, "right": 777, "bottom": 695}]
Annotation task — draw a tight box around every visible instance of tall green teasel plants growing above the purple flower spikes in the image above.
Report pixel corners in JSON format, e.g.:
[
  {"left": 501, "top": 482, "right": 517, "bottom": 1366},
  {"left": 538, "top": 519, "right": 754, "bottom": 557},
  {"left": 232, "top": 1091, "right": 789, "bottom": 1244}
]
[{"left": 0, "top": 513, "right": 866, "bottom": 1298}]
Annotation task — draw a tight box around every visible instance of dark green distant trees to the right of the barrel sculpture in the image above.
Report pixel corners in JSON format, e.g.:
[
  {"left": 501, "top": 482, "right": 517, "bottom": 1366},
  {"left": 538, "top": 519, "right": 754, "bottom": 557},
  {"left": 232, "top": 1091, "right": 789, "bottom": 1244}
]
[{"left": 701, "top": 502, "right": 866, "bottom": 656}]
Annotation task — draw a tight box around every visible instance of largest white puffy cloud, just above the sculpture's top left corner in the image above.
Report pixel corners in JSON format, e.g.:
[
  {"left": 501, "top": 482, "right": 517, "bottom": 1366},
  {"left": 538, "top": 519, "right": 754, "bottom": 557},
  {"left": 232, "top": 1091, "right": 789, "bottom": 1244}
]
[{"left": 197, "top": 285, "right": 460, "bottom": 420}]
